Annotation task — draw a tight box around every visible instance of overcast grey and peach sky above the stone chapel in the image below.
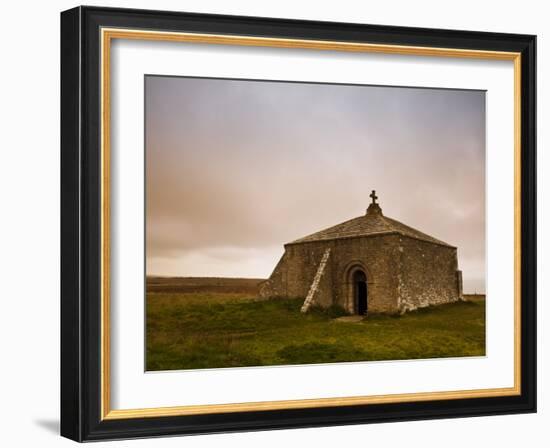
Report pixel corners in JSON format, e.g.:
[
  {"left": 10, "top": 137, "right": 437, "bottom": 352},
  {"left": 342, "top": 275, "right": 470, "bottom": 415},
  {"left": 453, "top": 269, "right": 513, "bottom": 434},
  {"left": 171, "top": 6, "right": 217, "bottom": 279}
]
[{"left": 145, "top": 76, "right": 485, "bottom": 292}]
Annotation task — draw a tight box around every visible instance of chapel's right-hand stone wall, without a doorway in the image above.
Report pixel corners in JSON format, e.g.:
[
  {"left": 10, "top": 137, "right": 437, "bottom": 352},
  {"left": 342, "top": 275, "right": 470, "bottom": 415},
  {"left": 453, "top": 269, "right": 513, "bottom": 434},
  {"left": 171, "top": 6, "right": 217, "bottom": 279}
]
[{"left": 398, "top": 237, "right": 462, "bottom": 312}]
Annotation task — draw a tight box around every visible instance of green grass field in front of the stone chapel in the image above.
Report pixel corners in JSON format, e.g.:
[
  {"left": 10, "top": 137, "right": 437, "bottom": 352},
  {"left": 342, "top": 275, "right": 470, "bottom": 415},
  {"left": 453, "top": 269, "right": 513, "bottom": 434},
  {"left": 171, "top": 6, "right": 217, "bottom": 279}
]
[{"left": 147, "top": 293, "right": 485, "bottom": 370}]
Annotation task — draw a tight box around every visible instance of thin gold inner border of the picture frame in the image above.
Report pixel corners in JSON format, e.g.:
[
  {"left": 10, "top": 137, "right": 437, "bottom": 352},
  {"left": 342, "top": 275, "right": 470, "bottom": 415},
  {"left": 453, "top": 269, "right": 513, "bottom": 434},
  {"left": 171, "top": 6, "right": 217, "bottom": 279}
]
[{"left": 100, "top": 28, "right": 521, "bottom": 420}]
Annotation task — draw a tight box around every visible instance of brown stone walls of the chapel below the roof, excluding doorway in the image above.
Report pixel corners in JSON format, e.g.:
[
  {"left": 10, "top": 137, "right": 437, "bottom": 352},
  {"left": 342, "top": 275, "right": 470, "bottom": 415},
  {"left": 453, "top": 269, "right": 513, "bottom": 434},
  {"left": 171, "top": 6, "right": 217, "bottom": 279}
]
[{"left": 260, "top": 234, "right": 462, "bottom": 313}]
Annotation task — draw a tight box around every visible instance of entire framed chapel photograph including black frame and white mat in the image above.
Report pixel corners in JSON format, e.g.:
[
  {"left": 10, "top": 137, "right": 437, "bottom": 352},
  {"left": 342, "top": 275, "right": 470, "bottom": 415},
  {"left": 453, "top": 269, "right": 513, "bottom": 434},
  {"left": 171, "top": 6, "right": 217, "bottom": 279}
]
[{"left": 61, "top": 7, "right": 536, "bottom": 441}]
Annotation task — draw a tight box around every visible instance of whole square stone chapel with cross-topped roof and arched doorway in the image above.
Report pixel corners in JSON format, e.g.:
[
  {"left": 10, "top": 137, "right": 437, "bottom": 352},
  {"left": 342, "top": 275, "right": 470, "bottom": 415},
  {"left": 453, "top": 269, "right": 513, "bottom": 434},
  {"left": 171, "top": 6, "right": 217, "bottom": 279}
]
[{"left": 260, "top": 191, "right": 462, "bottom": 314}]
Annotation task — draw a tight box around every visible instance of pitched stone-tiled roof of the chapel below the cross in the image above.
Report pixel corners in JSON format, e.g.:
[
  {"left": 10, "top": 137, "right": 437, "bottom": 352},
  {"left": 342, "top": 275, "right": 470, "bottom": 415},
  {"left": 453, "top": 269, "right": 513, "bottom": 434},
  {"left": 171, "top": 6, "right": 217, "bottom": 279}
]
[{"left": 288, "top": 203, "right": 454, "bottom": 247}]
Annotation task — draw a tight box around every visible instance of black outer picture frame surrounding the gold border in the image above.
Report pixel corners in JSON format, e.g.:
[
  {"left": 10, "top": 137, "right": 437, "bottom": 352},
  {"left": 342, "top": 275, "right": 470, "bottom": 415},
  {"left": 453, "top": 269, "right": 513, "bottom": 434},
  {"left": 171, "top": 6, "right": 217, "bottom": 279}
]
[{"left": 61, "top": 7, "right": 536, "bottom": 441}]
